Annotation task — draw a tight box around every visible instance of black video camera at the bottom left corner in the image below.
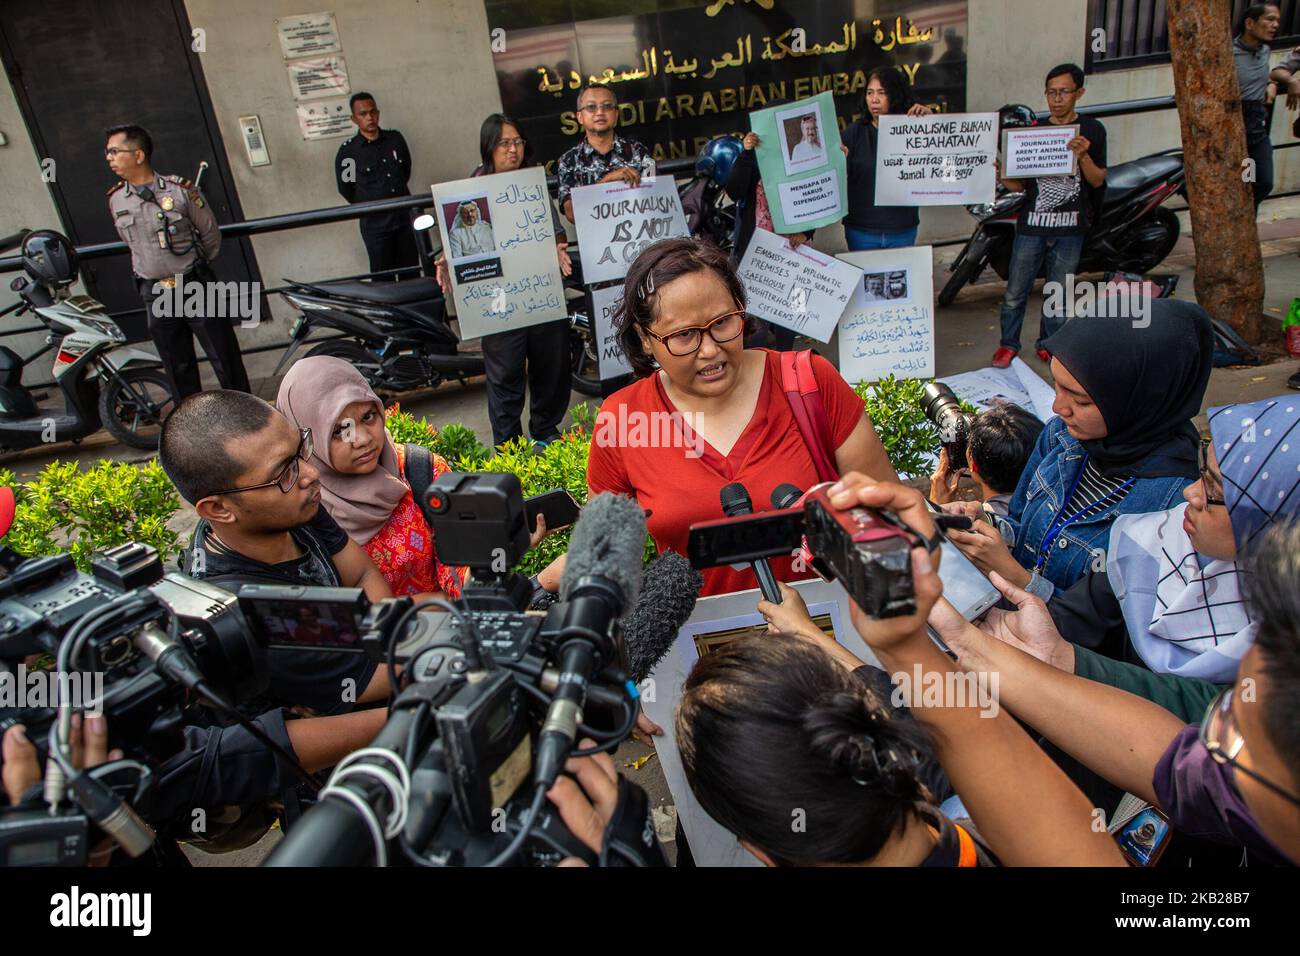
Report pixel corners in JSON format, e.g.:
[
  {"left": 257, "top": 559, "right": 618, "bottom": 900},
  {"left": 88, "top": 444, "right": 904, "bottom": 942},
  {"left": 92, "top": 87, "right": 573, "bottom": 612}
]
[{"left": 0, "top": 544, "right": 269, "bottom": 865}]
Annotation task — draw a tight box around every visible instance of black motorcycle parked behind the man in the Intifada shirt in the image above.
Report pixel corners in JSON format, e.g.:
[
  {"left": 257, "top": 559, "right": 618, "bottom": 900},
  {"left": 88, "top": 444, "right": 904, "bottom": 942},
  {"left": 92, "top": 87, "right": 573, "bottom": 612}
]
[{"left": 939, "top": 107, "right": 1187, "bottom": 306}]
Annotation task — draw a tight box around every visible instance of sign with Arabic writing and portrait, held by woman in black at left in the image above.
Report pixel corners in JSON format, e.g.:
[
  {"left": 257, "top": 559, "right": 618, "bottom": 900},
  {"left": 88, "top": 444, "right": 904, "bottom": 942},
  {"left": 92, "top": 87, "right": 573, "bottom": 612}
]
[{"left": 433, "top": 168, "right": 568, "bottom": 338}]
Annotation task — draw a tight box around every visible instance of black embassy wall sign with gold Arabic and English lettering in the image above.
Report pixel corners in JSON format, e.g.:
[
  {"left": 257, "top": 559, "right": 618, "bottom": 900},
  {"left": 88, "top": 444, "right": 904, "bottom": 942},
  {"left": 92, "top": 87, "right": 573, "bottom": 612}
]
[{"left": 485, "top": 0, "right": 967, "bottom": 172}]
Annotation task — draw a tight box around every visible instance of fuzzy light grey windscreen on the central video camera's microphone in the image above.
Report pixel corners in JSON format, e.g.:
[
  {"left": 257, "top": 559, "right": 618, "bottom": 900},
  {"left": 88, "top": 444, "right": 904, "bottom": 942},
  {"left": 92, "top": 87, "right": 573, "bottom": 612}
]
[{"left": 560, "top": 492, "right": 646, "bottom": 607}]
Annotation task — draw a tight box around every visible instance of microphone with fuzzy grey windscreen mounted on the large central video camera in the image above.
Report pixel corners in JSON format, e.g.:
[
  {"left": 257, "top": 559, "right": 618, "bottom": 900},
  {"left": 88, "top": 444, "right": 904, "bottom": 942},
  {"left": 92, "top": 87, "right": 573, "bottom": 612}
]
[{"left": 533, "top": 493, "right": 646, "bottom": 790}]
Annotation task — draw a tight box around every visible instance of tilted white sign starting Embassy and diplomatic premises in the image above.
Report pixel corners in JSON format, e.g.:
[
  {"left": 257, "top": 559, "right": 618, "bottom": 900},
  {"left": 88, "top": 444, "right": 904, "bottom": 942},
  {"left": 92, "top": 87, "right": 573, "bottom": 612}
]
[{"left": 737, "top": 229, "right": 862, "bottom": 342}]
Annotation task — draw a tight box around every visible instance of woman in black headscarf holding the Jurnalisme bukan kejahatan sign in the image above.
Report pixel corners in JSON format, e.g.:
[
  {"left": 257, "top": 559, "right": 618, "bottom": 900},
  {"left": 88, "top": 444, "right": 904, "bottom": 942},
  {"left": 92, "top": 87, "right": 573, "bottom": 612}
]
[{"left": 840, "top": 66, "right": 933, "bottom": 252}]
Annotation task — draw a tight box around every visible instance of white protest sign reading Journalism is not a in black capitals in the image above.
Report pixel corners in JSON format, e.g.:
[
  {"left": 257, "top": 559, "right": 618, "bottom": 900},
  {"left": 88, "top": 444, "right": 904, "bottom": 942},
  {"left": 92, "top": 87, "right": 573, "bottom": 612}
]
[{"left": 569, "top": 176, "right": 690, "bottom": 285}]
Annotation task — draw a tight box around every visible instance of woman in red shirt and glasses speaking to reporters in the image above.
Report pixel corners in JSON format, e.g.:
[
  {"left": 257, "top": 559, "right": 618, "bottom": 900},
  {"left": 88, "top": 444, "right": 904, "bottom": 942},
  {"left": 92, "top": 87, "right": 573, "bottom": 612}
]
[{"left": 586, "top": 239, "right": 897, "bottom": 594}]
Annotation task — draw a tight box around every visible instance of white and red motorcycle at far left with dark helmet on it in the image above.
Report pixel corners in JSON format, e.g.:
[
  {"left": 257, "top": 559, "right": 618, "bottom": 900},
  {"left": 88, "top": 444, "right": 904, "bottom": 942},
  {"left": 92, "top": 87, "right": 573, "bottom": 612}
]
[{"left": 0, "top": 230, "right": 176, "bottom": 451}]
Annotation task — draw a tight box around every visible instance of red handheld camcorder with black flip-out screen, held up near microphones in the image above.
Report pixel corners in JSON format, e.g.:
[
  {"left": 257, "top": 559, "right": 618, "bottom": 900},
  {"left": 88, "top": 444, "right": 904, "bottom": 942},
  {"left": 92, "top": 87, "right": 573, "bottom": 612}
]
[{"left": 688, "top": 484, "right": 946, "bottom": 618}]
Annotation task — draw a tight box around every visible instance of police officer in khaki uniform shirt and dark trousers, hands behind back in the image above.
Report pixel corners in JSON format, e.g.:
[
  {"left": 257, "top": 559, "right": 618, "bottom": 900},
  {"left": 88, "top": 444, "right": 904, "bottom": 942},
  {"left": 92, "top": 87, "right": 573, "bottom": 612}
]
[{"left": 104, "top": 126, "right": 251, "bottom": 401}]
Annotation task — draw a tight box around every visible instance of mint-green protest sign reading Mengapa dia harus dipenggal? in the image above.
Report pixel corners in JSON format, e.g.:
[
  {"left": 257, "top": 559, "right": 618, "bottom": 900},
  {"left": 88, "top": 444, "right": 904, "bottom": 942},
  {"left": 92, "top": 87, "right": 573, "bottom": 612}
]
[{"left": 749, "top": 92, "right": 848, "bottom": 234}]
